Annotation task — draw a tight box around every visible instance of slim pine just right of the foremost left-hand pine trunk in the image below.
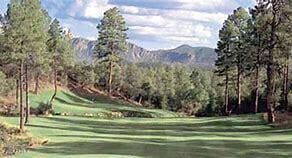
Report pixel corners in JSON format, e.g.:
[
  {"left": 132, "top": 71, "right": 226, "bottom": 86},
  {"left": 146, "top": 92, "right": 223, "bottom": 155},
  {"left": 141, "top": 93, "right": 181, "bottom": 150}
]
[{"left": 22, "top": 0, "right": 47, "bottom": 123}]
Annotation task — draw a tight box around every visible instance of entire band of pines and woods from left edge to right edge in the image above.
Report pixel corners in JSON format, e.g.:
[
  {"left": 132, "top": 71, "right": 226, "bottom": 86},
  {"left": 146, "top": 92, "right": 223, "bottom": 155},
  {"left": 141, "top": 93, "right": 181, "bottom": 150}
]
[{"left": 0, "top": 0, "right": 292, "bottom": 132}]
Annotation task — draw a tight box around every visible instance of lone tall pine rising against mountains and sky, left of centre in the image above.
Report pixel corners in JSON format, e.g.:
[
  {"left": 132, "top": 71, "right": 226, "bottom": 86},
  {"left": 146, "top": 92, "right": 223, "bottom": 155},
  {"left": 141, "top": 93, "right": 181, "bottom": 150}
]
[{"left": 96, "top": 7, "right": 127, "bottom": 94}]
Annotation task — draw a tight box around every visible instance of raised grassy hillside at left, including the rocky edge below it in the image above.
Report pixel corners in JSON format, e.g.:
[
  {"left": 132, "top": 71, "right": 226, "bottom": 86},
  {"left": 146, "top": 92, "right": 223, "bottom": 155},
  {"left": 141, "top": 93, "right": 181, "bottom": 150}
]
[{"left": 30, "top": 90, "right": 177, "bottom": 118}]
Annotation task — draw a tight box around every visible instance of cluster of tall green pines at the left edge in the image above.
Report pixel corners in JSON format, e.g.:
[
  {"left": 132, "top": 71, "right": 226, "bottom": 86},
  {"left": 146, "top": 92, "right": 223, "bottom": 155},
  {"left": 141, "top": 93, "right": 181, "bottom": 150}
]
[{"left": 0, "top": 0, "right": 74, "bottom": 130}]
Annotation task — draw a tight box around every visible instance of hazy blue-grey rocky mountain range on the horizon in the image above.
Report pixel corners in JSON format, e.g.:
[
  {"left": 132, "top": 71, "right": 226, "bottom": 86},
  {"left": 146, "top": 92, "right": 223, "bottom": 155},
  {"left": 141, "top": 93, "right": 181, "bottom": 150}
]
[{"left": 72, "top": 38, "right": 217, "bottom": 67}]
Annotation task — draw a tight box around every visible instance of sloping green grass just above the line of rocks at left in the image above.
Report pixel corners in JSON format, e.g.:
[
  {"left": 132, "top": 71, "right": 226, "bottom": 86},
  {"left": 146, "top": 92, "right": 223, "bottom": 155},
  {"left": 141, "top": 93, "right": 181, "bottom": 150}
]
[{"left": 30, "top": 90, "right": 177, "bottom": 117}]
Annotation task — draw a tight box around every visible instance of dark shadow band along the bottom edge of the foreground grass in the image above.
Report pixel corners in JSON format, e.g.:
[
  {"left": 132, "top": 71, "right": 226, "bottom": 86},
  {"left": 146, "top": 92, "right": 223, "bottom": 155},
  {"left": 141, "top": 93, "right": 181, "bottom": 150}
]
[{"left": 29, "top": 139, "right": 292, "bottom": 158}]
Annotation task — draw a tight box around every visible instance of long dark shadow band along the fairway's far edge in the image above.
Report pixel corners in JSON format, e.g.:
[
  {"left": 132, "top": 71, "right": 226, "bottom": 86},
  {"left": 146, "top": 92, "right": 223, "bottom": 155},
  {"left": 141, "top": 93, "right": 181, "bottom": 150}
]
[{"left": 47, "top": 117, "right": 272, "bottom": 133}]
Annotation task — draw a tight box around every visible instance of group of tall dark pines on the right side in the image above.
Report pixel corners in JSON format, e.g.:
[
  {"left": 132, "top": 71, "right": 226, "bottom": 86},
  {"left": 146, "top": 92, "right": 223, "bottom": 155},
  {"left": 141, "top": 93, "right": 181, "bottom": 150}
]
[{"left": 216, "top": 0, "right": 292, "bottom": 122}]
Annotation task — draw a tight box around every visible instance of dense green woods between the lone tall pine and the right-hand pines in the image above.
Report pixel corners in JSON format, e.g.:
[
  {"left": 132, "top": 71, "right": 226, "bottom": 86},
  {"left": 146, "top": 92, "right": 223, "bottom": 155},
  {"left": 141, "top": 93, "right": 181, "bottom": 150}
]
[{"left": 106, "top": 64, "right": 217, "bottom": 116}]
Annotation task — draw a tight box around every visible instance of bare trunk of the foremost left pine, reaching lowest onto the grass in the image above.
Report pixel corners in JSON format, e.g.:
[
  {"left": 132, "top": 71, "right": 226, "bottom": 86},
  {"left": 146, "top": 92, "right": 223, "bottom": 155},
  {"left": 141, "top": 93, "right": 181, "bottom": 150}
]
[{"left": 19, "top": 61, "right": 24, "bottom": 131}]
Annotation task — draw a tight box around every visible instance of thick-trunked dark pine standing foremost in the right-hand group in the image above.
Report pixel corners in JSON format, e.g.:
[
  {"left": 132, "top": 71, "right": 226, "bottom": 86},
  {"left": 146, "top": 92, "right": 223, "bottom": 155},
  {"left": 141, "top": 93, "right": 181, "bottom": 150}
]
[{"left": 258, "top": 0, "right": 285, "bottom": 122}]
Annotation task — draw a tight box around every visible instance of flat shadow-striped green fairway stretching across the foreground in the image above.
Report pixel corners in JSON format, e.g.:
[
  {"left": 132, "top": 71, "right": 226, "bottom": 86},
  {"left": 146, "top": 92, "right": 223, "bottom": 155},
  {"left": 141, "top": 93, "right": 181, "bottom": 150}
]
[{"left": 0, "top": 115, "right": 292, "bottom": 158}]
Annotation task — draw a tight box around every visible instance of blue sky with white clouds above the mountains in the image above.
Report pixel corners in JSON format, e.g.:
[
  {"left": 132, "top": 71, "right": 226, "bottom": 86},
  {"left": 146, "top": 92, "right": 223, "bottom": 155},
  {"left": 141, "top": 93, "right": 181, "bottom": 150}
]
[{"left": 0, "top": 0, "right": 255, "bottom": 50}]
